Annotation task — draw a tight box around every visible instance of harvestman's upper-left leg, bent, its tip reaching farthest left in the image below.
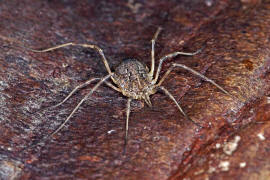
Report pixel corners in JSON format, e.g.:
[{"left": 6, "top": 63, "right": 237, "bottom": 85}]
[{"left": 27, "top": 42, "right": 112, "bottom": 74}]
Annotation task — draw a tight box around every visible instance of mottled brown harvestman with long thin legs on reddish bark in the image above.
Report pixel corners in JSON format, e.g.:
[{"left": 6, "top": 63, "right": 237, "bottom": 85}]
[{"left": 30, "top": 28, "right": 230, "bottom": 149}]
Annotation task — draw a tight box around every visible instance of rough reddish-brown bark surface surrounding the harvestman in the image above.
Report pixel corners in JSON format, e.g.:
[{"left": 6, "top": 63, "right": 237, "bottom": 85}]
[{"left": 0, "top": 0, "right": 270, "bottom": 179}]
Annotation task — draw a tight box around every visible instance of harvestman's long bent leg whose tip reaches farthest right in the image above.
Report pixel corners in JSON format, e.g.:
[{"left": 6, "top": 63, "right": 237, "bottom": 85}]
[{"left": 157, "top": 63, "right": 232, "bottom": 96}]
